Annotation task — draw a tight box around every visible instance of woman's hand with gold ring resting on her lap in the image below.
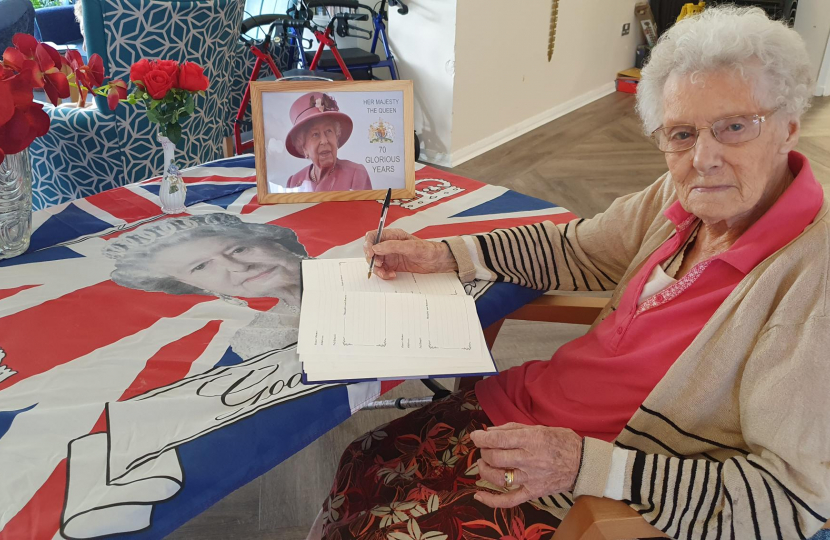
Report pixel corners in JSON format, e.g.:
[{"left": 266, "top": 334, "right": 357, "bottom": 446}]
[{"left": 470, "top": 422, "right": 582, "bottom": 508}]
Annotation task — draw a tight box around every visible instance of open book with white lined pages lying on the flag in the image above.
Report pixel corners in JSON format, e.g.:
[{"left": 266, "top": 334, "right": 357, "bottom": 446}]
[{"left": 297, "top": 259, "right": 496, "bottom": 383}]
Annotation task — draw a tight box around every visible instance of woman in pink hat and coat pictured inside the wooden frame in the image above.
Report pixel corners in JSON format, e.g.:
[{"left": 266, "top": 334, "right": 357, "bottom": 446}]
[{"left": 285, "top": 92, "right": 372, "bottom": 192}]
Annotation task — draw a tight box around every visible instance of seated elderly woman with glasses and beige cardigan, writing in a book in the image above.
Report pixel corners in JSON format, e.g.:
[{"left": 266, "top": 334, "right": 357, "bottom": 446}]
[{"left": 320, "top": 7, "right": 830, "bottom": 540}]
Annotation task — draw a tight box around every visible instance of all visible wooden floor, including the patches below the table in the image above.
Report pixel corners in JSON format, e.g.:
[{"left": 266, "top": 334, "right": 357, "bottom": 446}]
[{"left": 168, "top": 90, "right": 830, "bottom": 540}]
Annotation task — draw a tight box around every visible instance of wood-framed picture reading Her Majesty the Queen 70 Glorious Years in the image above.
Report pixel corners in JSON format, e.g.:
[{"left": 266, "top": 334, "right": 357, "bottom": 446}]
[{"left": 251, "top": 81, "right": 415, "bottom": 204}]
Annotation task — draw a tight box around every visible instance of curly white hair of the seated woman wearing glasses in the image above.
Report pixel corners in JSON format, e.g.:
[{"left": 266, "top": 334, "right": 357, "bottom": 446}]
[{"left": 637, "top": 5, "right": 813, "bottom": 134}]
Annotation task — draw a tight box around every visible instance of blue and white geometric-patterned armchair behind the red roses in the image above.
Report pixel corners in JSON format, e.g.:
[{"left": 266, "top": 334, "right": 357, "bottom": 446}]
[{"left": 30, "top": 0, "right": 243, "bottom": 209}]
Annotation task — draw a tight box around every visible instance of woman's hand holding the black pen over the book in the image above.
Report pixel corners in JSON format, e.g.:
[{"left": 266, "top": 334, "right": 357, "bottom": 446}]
[{"left": 363, "top": 229, "right": 458, "bottom": 279}]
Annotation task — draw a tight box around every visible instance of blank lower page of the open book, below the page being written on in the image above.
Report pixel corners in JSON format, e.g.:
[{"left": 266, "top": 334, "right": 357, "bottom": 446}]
[{"left": 297, "top": 290, "right": 481, "bottom": 359}]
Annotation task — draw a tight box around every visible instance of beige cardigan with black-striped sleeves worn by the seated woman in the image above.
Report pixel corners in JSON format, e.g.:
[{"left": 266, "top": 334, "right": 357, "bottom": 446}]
[{"left": 447, "top": 174, "right": 830, "bottom": 539}]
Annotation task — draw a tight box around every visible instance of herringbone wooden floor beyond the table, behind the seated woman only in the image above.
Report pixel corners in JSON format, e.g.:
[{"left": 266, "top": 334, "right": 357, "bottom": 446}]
[{"left": 452, "top": 89, "right": 830, "bottom": 217}]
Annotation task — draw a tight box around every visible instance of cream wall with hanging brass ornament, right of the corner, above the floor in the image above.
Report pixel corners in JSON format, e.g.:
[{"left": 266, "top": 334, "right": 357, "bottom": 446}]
[{"left": 452, "top": 0, "right": 648, "bottom": 166}]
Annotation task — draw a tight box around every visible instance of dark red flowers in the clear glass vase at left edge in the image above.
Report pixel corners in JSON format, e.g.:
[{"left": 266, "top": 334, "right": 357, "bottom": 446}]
[{"left": 0, "top": 34, "right": 127, "bottom": 163}]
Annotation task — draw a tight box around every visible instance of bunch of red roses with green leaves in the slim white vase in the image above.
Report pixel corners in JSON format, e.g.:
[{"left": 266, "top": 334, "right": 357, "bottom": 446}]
[{"left": 127, "top": 59, "right": 210, "bottom": 144}]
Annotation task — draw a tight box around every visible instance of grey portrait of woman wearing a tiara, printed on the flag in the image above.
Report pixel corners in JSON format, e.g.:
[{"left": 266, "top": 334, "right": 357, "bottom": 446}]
[{"left": 103, "top": 213, "right": 307, "bottom": 359}]
